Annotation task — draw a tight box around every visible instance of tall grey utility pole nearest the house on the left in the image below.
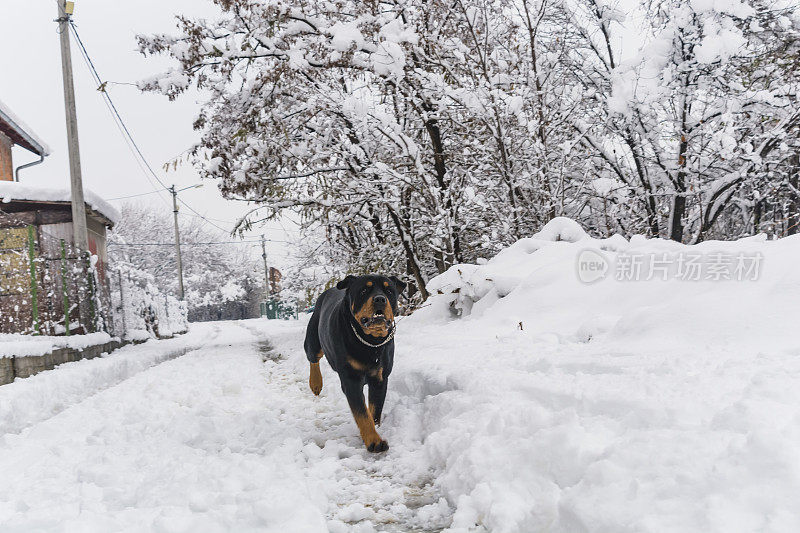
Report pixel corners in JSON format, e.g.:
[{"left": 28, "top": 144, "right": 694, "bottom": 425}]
[{"left": 56, "top": 0, "right": 89, "bottom": 252}]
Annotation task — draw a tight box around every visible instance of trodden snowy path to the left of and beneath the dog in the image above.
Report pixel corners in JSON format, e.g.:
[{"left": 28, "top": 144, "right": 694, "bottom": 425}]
[{"left": 0, "top": 322, "right": 450, "bottom": 531}]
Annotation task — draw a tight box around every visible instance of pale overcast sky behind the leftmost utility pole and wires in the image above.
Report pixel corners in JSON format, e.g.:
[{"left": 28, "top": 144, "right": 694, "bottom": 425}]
[{"left": 0, "top": 0, "right": 291, "bottom": 266}]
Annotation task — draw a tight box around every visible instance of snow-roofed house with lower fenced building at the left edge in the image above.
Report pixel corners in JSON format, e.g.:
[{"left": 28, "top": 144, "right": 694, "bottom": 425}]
[{"left": 0, "top": 102, "right": 118, "bottom": 335}]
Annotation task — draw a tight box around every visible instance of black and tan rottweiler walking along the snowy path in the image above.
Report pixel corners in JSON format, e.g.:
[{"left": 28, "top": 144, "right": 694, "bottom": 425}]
[{"left": 304, "top": 275, "right": 406, "bottom": 452}]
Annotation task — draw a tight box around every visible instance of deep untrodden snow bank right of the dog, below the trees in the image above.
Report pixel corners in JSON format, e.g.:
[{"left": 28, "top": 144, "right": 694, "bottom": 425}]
[{"left": 396, "top": 219, "right": 800, "bottom": 533}]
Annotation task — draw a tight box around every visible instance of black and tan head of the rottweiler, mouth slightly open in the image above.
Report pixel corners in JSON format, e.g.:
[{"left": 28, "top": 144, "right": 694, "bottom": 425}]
[{"left": 336, "top": 274, "right": 406, "bottom": 337}]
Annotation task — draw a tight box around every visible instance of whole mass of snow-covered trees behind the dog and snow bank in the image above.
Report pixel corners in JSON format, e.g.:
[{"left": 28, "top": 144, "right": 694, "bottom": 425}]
[{"left": 139, "top": 0, "right": 800, "bottom": 299}]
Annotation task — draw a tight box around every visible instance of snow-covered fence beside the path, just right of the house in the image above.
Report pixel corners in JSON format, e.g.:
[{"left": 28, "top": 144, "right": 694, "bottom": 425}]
[{"left": 110, "top": 262, "right": 189, "bottom": 340}]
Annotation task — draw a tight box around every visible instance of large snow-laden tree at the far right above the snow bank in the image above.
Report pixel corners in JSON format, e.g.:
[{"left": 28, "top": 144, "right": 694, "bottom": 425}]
[{"left": 572, "top": 0, "right": 800, "bottom": 241}]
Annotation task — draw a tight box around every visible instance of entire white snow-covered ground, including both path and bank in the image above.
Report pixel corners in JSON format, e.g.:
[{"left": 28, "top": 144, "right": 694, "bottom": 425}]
[{"left": 0, "top": 220, "right": 800, "bottom": 533}]
